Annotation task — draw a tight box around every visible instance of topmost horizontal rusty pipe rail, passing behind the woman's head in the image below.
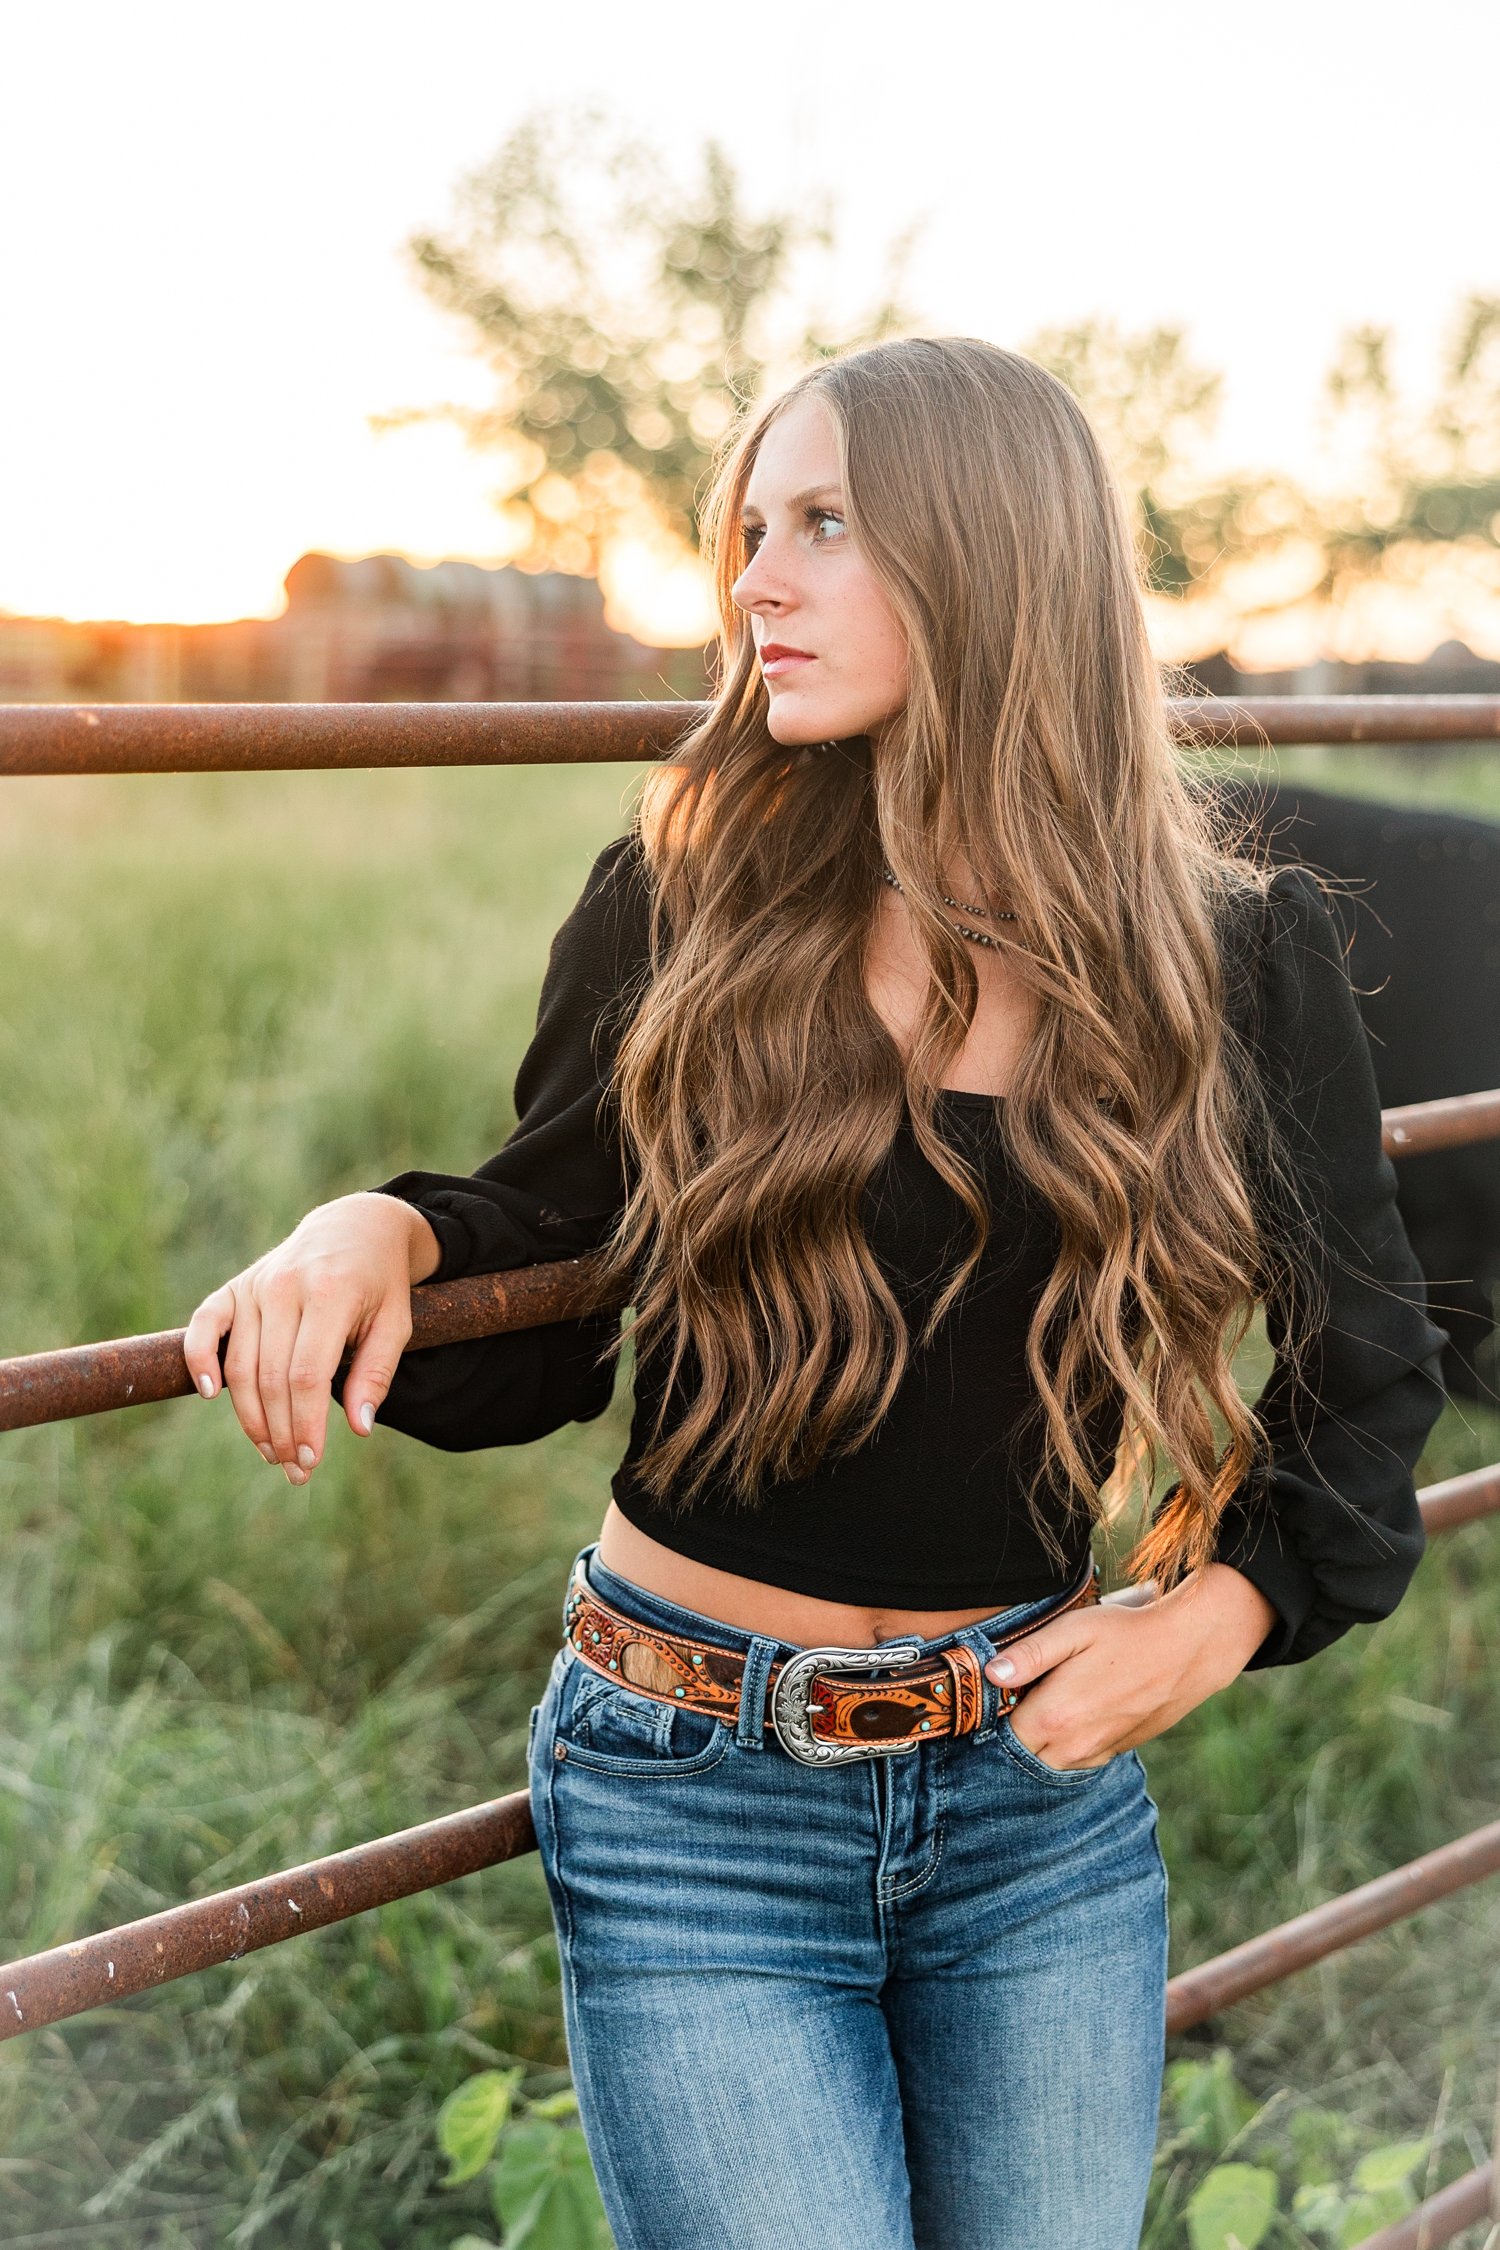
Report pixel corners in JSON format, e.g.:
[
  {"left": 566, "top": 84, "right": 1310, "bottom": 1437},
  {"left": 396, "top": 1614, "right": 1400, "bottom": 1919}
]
[{"left": 0, "top": 695, "right": 1500, "bottom": 776}]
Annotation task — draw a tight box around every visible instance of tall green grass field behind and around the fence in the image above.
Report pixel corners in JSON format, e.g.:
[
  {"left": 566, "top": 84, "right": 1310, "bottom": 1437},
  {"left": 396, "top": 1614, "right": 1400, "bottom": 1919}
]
[{"left": 0, "top": 752, "right": 1500, "bottom": 2250}]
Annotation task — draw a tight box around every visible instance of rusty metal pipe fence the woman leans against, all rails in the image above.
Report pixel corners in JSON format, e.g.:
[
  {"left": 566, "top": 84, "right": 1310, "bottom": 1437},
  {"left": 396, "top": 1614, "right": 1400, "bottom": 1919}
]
[{"left": 0, "top": 695, "right": 1500, "bottom": 2250}]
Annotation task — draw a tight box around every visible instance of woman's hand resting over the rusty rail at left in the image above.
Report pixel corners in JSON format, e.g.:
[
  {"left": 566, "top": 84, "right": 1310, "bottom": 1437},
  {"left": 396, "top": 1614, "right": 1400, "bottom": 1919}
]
[{"left": 182, "top": 1195, "right": 441, "bottom": 1485}]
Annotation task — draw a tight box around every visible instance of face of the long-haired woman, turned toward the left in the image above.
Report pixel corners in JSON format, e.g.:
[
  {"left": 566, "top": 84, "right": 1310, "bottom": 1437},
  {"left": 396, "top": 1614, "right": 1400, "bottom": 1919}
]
[{"left": 735, "top": 394, "right": 906, "bottom": 745}]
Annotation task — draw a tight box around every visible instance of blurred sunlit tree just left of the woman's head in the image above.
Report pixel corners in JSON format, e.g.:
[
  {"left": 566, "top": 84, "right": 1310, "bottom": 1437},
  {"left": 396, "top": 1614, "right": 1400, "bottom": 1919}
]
[{"left": 398, "top": 115, "right": 906, "bottom": 572}]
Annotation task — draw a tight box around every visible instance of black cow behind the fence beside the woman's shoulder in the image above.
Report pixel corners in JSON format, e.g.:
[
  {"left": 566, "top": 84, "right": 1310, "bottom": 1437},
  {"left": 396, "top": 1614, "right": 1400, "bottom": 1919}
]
[{"left": 1221, "top": 783, "right": 1500, "bottom": 1402}]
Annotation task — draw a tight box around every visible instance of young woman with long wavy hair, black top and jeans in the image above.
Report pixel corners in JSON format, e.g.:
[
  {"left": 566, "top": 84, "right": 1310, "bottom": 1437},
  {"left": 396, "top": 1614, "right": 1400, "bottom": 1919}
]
[{"left": 189, "top": 342, "right": 1442, "bottom": 2250}]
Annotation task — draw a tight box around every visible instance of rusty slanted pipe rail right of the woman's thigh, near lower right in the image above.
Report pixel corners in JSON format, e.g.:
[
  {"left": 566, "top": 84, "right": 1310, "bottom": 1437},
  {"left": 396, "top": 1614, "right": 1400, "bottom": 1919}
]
[{"left": 1167, "top": 1820, "right": 1500, "bottom": 2032}]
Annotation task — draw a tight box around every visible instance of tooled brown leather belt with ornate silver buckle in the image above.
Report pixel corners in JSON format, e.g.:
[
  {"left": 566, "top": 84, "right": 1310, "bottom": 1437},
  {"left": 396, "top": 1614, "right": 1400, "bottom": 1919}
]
[{"left": 564, "top": 1566, "right": 1100, "bottom": 1766}]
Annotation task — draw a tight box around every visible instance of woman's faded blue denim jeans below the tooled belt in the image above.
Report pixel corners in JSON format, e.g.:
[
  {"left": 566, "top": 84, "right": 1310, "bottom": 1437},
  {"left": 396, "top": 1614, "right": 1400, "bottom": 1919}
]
[{"left": 531, "top": 1553, "right": 1167, "bottom": 2250}]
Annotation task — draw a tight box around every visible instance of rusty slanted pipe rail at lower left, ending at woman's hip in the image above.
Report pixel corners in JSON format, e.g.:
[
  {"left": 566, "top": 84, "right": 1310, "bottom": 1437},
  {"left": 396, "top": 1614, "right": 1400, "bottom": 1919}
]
[{"left": 0, "top": 1789, "right": 537, "bottom": 2039}]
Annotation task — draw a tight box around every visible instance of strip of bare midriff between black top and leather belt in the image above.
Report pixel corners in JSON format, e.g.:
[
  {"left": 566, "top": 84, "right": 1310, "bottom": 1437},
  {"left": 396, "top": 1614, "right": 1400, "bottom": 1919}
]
[{"left": 598, "top": 1501, "right": 1003, "bottom": 1649}]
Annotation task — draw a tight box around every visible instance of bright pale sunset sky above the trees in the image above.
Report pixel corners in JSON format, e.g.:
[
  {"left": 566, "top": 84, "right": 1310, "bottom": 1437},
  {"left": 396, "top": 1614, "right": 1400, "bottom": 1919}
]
[{"left": 0, "top": 0, "right": 1500, "bottom": 623}]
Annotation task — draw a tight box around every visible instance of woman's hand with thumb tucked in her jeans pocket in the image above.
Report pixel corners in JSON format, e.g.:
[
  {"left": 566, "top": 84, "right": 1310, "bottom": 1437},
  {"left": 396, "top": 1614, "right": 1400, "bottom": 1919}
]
[{"left": 985, "top": 1562, "right": 1275, "bottom": 1773}]
